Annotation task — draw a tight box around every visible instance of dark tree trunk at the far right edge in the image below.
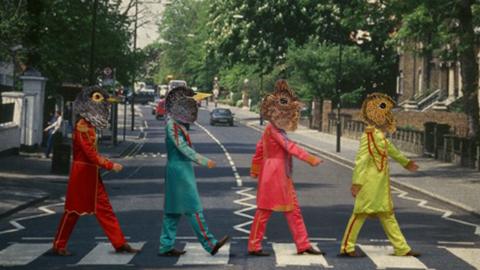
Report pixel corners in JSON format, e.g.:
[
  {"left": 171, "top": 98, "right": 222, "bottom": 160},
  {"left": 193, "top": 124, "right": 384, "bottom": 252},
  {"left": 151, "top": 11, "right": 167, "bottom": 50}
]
[{"left": 458, "top": 0, "right": 480, "bottom": 141}]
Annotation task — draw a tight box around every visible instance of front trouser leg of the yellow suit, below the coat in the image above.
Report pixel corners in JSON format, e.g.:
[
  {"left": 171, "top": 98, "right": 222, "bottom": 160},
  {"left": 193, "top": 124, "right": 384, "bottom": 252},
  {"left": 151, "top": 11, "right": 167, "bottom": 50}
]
[{"left": 379, "top": 213, "right": 411, "bottom": 256}]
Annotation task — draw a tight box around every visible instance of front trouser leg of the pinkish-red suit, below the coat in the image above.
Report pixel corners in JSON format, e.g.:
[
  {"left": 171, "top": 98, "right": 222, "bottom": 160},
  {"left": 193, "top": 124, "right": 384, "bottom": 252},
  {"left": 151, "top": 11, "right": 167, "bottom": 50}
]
[{"left": 284, "top": 197, "right": 311, "bottom": 252}]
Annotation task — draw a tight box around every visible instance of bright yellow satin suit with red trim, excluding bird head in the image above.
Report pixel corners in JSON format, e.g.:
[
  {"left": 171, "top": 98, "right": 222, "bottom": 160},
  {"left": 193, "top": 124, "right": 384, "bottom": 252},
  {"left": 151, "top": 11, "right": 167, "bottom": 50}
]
[{"left": 340, "top": 126, "right": 411, "bottom": 255}]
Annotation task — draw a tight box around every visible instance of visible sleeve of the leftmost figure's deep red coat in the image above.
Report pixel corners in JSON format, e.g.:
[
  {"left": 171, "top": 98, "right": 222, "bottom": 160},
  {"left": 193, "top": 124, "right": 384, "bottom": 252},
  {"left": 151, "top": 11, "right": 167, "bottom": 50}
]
[{"left": 76, "top": 122, "right": 113, "bottom": 170}]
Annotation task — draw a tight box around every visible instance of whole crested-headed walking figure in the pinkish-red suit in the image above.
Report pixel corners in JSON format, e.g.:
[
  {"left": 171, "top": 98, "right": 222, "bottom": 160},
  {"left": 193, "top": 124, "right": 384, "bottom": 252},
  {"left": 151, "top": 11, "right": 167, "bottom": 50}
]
[{"left": 248, "top": 80, "right": 325, "bottom": 256}]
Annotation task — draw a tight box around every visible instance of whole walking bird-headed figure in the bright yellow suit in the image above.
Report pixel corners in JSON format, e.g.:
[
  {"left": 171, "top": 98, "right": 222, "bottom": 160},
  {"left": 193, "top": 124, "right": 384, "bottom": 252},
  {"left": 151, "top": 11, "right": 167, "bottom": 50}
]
[{"left": 340, "top": 93, "right": 420, "bottom": 257}]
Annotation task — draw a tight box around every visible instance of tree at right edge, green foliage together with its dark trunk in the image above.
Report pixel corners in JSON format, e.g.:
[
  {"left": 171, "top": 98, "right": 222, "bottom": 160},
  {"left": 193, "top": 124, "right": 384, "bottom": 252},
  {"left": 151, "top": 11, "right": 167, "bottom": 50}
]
[{"left": 395, "top": 0, "right": 480, "bottom": 140}]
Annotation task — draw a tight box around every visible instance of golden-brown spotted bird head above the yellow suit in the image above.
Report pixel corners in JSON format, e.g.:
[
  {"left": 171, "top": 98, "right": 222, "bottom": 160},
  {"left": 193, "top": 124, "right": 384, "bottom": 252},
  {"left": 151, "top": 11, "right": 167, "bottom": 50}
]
[{"left": 362, "top": 93, "right": 397, "bottom": 133}]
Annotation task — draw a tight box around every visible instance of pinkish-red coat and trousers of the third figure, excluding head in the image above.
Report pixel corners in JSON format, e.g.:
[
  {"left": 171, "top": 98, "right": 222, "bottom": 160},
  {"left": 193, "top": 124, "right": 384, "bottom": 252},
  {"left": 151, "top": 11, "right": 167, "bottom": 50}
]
[{"left": 248, "top": 124, "right": 316, "bottom": 252}]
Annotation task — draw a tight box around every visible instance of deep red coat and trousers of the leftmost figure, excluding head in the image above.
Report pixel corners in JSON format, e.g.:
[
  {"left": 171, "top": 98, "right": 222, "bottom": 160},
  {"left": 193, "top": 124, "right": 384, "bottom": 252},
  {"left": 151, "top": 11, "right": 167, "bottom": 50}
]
[{"left": 53, "top": 119, "right": 126, "bottom": 250}]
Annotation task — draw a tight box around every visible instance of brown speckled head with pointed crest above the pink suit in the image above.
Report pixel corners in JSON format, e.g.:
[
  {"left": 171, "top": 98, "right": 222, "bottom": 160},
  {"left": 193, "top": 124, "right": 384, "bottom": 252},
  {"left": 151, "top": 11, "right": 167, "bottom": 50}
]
[{"left": 261, "top": 80, "right": 300, "bottom": 131}]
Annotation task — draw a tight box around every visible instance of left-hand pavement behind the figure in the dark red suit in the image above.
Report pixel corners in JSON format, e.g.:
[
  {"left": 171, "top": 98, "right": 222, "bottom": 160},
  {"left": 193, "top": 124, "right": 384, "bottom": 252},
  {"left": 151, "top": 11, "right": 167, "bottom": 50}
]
[{"left": 0, "top": 103, "right": 142, "bottom": 219}]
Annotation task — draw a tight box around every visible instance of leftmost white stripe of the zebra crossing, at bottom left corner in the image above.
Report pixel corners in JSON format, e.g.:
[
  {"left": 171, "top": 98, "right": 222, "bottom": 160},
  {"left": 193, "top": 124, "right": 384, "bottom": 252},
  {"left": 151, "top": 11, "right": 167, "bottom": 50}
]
[{"left": 0, "top": 243, "right": 52, "bottom": 266}]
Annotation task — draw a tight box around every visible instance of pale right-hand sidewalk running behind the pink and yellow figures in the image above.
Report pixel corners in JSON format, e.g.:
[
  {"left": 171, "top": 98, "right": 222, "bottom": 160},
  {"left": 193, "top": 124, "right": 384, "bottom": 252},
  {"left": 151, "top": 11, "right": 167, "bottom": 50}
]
[{"left": 208, "top": 104, "right": 480, "bottom": 216}]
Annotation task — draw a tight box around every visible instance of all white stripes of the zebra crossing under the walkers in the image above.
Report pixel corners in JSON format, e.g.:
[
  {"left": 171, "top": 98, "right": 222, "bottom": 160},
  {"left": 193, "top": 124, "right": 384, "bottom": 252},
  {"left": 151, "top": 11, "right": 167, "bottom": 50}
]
[{"left": 0, "top": 241, "right": 480, "bottom": 269}]
